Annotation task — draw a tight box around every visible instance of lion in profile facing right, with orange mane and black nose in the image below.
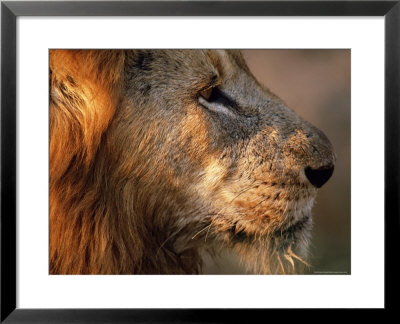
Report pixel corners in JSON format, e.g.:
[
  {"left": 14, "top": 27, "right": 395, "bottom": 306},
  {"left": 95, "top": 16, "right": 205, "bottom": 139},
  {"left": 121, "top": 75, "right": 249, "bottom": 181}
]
[{"left": 49, "top": 49, "right": 336, "bottom": 274}]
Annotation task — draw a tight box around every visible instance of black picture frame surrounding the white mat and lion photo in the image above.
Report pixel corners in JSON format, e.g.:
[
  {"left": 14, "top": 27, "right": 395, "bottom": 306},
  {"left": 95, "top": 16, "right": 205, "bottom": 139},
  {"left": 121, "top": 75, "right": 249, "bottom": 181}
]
[{"left": 0, "top": 0, "right": 400, "bottom": 323}]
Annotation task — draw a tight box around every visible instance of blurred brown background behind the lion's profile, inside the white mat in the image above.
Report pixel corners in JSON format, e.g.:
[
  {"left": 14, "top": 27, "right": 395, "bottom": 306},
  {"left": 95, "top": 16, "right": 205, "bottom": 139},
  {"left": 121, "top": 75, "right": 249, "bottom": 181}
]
[{"left": 205, "top": 50, "right": 351, "bottom": 274}]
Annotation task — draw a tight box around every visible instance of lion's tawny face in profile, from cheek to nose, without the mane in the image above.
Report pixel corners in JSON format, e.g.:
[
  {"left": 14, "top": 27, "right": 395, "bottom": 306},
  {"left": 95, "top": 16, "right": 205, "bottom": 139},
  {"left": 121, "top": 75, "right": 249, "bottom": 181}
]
[{"left": 101, "top": 50, "right": 335, "bottom": 272}]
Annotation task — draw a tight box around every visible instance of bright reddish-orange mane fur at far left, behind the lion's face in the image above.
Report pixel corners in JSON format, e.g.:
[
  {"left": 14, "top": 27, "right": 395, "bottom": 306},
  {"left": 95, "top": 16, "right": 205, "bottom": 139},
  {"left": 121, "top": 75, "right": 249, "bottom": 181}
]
[{"left": 50, "top": 50, "right": 124, "bottom": 273}]
